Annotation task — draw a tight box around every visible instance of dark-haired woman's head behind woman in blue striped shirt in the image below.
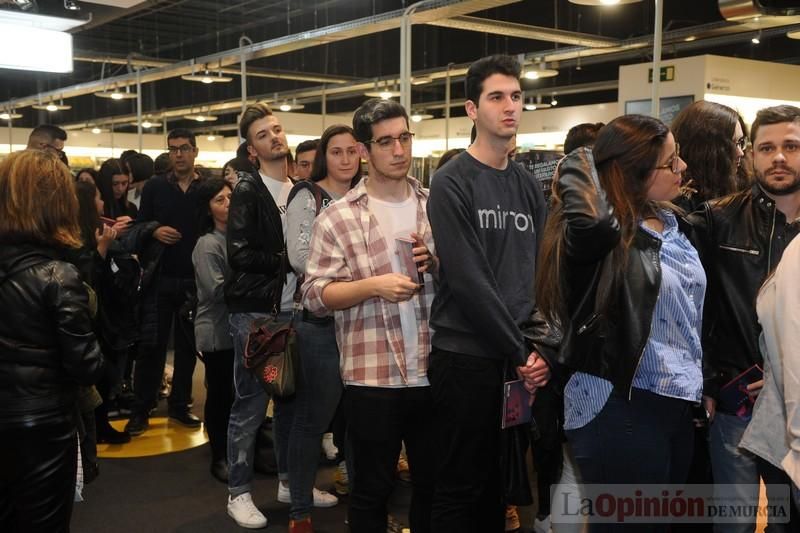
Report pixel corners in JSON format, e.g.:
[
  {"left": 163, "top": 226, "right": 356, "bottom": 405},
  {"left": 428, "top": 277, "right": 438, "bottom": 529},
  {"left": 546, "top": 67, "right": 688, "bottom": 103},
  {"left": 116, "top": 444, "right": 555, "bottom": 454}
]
[{"left": 672, "top": 100, "right": 749, "bottom": 213}]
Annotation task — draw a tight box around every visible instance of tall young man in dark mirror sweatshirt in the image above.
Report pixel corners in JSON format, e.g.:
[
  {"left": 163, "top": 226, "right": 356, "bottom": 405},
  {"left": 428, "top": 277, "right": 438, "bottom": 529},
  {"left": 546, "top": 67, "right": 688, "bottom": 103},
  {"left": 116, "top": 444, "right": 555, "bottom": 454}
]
[{"left": 428, "top": 56, "right": 550, "bottom": 533}]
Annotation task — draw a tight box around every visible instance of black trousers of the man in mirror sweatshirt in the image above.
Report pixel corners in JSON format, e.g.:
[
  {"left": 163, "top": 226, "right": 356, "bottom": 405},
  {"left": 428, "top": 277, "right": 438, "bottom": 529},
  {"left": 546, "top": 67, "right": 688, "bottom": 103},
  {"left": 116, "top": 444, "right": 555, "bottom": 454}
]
[{"left": 428, "top": 348, "right": 505, "bottom": 533}]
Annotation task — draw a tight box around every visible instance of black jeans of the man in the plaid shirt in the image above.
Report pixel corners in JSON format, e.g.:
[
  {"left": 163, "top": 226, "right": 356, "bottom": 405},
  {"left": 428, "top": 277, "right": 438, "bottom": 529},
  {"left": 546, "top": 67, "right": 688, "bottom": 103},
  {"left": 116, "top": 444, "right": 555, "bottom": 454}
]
[{"left": 344, "top": 386, "right": 434, "bottom": 533}]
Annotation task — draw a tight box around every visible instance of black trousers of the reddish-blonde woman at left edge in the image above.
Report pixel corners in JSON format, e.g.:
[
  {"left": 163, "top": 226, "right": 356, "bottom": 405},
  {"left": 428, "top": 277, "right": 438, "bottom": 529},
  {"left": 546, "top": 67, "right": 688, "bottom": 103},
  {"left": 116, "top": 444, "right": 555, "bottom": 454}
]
[{"left": 0, "top": 419, "right": 78, "bottom": 533}]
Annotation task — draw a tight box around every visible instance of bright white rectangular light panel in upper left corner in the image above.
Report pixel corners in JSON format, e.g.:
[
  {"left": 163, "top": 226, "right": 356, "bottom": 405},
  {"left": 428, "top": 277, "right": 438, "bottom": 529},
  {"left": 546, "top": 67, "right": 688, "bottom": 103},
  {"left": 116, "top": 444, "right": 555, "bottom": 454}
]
[{"left": 0, "top": 22, "right": 72, "bottom": 73}]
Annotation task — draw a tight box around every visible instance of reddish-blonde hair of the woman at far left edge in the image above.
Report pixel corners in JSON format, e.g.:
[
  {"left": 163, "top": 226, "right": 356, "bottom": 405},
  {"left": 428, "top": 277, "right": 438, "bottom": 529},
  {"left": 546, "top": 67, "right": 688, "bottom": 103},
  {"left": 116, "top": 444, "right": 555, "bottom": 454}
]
[{"left": 0, "top": 150, "right": 82, "bottom": 248}]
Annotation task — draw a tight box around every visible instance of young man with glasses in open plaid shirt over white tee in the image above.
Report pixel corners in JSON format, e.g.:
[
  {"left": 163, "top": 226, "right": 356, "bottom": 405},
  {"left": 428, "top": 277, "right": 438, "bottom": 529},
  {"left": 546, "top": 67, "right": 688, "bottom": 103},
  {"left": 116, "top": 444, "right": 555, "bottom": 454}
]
[{"left": 303, "top": 99, "right": 436, "bottom": 533}]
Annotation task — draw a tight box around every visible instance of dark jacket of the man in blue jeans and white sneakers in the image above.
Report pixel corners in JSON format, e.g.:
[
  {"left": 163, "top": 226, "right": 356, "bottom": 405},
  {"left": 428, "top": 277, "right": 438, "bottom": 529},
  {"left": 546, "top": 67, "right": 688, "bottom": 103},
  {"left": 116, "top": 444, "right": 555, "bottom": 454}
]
[{"left": 225, "top": 169, "right": 289, "bottom": 313}]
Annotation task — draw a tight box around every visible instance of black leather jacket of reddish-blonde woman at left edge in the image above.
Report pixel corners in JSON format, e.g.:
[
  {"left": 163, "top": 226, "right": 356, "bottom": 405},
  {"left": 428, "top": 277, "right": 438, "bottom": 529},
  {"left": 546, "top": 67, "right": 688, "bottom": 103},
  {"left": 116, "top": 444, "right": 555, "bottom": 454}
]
[{"left": 0, "top": 244, "right": 103, "bottom": 428}]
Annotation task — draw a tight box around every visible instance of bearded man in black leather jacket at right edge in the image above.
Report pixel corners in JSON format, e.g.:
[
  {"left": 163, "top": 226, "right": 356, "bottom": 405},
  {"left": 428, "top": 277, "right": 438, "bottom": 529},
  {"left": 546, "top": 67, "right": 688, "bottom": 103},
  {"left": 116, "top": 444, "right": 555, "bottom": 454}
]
[{"left": 692, "top": 105, "right": 800, "bottom": 532}]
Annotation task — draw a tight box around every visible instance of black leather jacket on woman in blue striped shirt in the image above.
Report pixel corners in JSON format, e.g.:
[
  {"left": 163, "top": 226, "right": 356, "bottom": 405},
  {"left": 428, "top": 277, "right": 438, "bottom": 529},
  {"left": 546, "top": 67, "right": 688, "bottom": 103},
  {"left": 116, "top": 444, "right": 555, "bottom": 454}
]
[{"left": 556, "top": 148, "right": 691, "bottom": 396}]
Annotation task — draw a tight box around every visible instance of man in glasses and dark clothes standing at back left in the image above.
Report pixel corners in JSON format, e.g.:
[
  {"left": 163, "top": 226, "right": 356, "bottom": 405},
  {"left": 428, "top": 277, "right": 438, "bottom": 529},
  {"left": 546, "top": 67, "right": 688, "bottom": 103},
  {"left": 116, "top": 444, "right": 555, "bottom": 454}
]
[{"left": 125, "top": 129, "right": 206, "bottom": 436}]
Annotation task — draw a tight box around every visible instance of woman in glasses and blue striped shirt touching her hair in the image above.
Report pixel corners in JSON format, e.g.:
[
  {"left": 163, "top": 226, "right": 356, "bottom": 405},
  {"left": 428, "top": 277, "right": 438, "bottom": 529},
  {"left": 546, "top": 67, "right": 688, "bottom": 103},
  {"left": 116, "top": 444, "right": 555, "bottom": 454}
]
[{"left": 536, "top": 115, "right": 706, "bottom": 531}]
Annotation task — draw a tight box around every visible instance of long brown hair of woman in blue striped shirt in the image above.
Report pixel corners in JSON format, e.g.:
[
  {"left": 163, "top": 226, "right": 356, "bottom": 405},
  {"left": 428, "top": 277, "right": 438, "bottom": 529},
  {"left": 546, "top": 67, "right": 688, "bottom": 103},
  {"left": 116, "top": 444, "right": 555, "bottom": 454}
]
[{"left": 536, "top": 115, "right": 669, "bottom": 325}]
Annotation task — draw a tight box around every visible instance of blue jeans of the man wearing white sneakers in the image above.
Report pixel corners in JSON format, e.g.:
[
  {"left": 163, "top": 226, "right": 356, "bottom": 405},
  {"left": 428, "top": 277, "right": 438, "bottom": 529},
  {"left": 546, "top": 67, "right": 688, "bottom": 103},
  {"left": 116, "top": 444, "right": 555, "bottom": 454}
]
[{"left": 228, "top": 313, "right": 294, "bottom": 498}]
